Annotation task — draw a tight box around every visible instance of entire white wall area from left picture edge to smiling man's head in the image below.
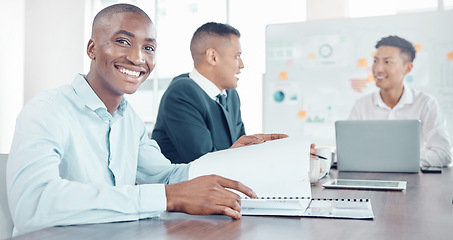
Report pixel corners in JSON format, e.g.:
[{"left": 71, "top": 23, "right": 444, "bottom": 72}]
[{"left": 0, "top": 0, "right": 89, "bottom": 153}]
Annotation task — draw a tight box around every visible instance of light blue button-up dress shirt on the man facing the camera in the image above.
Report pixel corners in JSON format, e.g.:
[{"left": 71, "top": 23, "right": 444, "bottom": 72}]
[{"left": 7, "top": 75, "right": 190, "bottom": 235}]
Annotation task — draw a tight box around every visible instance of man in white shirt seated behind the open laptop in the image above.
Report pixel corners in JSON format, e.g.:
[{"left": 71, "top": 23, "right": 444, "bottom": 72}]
[{"left": 349, "top": 36, "right": 451, "bottom": 167}]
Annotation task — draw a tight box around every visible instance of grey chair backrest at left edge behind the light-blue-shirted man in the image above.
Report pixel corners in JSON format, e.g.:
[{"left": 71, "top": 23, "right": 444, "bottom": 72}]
[{"left": 0, "top": 154, "right": 13, "bottom": 239}]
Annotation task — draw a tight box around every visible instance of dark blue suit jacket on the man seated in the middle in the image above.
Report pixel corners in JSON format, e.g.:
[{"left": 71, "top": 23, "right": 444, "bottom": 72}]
[{"left": 152, "top": 74, "right": 245, "bottom": 163}]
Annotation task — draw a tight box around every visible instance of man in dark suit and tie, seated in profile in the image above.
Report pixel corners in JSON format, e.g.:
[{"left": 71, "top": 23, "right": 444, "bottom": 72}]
[{"left": 152, "top": 22, "right": 287, "bottom": 163}]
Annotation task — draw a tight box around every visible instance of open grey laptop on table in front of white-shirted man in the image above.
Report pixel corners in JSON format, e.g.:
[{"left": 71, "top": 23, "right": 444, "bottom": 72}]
[{"left": 335, "top": 120, "right": 420, "bottom": 173}]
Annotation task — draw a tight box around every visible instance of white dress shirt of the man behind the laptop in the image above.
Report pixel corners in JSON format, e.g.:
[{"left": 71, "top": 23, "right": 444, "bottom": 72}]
[{"left": 349, "top": 85, "right": 451, "bottom": 166}]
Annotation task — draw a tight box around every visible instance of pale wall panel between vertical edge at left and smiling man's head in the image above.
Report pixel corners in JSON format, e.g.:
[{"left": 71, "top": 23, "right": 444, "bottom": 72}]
[{"left": 24, "top": 0, "right": 88, "bottom": 103}]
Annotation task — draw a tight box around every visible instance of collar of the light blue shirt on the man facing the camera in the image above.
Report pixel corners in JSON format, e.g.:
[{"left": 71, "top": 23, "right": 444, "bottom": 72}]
[{"left": 72, "top": 74, "right": 127, "bottom": 115}]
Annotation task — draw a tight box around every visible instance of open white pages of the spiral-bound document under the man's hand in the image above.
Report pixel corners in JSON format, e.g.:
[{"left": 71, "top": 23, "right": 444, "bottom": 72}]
[{"left": 189, "top": 137, "right": 311, "bottom": 216}]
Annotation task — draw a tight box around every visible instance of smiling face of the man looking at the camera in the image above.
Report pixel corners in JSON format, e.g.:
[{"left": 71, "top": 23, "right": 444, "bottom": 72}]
[{"left": 86, "top": 12, "right": 156, "bottom": 101}]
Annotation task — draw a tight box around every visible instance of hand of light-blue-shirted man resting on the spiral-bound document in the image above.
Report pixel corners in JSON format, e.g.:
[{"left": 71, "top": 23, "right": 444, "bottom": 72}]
[{"left": 165, "top": 175, "right": 256, "bottom": 219}]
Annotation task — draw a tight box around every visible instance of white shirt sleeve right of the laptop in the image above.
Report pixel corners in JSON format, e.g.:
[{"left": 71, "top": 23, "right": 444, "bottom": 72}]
[{"left": 420, "top": 98, "right": 451, "bottom": 167}]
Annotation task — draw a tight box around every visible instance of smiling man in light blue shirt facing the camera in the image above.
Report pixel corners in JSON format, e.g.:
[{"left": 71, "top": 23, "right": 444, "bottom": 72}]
[{"left": 7, "top": 4, "right": 256, "bottom": 235}]
